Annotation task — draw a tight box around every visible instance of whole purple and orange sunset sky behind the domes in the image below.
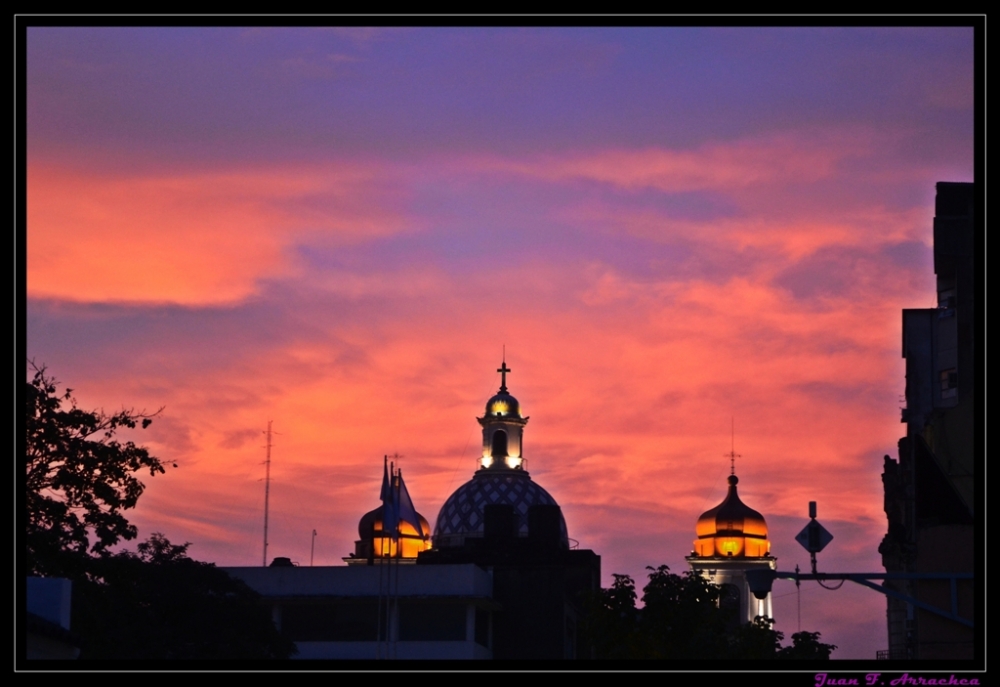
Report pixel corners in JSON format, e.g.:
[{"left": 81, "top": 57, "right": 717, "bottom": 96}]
[{"left": 26, "top": 27, "right": 974, "bottom": 658}]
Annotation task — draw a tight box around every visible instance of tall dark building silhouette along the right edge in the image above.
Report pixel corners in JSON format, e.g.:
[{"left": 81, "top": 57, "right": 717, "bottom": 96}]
[{"left": 879, "top": 182, "right": 982, "bottom": 659}]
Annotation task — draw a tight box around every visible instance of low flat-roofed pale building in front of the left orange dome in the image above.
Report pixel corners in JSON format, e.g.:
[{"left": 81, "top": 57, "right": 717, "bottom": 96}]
[{"left": 225, "top": 564, "right": 497, "bottom": 660}]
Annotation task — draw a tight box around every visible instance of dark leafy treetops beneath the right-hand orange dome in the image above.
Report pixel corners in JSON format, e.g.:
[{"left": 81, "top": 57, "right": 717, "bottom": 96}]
[{"left": 585, "top": 565, "right": 837, "bottom": 660}]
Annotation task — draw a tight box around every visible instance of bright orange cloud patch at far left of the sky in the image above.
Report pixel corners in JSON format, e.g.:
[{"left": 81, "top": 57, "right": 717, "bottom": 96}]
[{"left": 27, "top": 163, "right": 405, "bottom": 305}]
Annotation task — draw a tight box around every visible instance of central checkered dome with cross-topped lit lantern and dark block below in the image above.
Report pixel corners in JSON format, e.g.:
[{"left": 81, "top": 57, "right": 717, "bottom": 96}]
[{"left": 417, "top": 362, "right": 601, "bottom": 659}]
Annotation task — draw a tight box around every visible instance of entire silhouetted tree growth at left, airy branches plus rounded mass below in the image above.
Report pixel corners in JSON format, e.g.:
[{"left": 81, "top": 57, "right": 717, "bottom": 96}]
[{"left": 25, "top": 362, "right": 295, "bottom": 659}]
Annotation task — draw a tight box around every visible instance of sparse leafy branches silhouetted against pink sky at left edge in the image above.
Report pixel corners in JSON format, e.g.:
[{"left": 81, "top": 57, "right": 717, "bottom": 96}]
[{"left": 25, "top": 363, "right": 164, "bottom": 577}]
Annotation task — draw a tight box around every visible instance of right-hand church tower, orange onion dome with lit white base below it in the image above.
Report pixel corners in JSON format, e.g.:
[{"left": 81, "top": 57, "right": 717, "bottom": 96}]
[{"left": 686, "top": 469, "right": 777, "bottom": 623}]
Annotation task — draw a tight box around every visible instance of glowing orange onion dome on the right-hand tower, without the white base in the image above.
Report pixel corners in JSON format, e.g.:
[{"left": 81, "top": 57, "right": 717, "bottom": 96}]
[{"left": 693, "top": 475, "right": 771, "bottom": 558}]
